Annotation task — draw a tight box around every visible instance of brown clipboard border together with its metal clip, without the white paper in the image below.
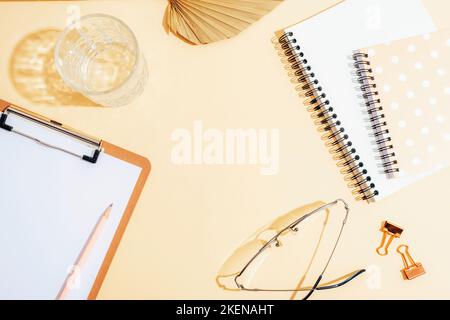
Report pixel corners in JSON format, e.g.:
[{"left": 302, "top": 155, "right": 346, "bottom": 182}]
[{"left": 0, "top": 100, "right": 151, "bottom": 300}]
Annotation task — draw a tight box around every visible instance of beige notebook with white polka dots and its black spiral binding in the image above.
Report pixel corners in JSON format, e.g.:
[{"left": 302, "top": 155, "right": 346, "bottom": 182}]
[{"left": 353, "top": 29, "right": 450, "bottom": 177}]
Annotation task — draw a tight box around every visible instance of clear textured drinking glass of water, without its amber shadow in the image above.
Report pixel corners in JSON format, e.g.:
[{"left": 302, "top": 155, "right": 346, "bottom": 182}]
[{"left": 55, "top": 14, "right": 148, "bottom": 107}]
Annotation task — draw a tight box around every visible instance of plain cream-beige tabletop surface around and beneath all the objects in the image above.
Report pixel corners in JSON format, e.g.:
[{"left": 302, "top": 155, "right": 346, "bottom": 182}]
[{"left": 0, "top": 0, "right": 450, "bottom": 299}]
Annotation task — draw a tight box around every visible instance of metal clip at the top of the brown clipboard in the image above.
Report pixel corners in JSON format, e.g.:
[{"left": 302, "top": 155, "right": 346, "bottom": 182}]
[{"left": 0, "top": 107, "right": 102, "bottom": 164}]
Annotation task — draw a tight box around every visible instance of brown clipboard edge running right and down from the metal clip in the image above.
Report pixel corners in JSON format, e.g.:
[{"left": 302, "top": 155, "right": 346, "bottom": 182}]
[{"left": 88, "top": 141, "right": 151, "bottom": 300}]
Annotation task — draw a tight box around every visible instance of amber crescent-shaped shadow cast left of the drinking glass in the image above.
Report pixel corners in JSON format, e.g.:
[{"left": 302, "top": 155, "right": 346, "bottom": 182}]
[{"left": 10, "top": 29, "right": 99, "bottom": 107}]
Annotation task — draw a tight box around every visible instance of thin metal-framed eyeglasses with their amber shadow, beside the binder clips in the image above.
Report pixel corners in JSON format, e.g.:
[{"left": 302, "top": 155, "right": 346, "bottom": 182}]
[{"left": 216, "top": 199, "right": 365, "bottom": 300}]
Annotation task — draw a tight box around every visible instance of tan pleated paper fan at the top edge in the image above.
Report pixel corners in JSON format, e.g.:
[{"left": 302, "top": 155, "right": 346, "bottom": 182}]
[{"left": 163, "top": 0, "right": 283, "bottom": 45}]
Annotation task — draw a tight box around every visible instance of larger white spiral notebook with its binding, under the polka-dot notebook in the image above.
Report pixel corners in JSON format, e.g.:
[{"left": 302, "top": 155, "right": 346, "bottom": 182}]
[{"left": 276, "top": 0, "right": 436, "bottom": 202}]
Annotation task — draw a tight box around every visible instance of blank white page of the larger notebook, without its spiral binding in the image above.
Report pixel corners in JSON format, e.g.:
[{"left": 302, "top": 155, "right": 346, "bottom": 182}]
[{"left": 285, "top": 0, "right": 435, "bottom": 199}]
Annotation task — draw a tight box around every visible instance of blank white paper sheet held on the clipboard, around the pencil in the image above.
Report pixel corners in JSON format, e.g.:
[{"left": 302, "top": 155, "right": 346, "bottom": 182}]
[{"left": 0, "top": 114, "right": 141, "bottom": 299}]
